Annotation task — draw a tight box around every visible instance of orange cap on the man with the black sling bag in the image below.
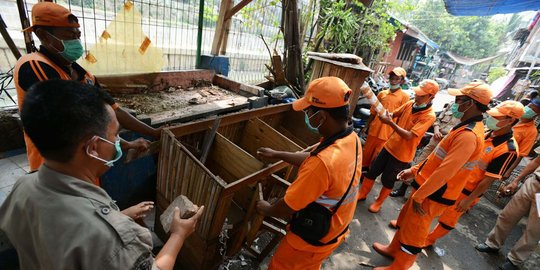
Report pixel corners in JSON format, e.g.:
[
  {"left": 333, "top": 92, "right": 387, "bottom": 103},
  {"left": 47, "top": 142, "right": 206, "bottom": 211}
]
[{"left": 293, "top": 77, "right": 352, "bottom": 111}]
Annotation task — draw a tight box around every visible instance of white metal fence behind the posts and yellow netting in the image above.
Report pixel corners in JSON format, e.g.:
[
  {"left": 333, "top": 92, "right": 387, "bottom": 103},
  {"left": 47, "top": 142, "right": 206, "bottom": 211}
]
[{"left": 15, "top": 0, "right": 283, "bottom": 83}]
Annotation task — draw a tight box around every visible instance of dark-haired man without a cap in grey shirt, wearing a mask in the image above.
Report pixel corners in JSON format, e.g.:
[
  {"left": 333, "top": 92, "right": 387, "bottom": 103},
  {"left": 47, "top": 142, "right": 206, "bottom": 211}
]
[{"left": 0, "top": 80, "right": 203, "bottom": 269}]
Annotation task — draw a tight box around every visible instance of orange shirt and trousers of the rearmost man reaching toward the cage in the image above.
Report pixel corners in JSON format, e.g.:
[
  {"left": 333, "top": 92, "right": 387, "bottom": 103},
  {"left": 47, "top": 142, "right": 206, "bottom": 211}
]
[{"left": 362, "top": 88, "right": 410, "bottom": 167}]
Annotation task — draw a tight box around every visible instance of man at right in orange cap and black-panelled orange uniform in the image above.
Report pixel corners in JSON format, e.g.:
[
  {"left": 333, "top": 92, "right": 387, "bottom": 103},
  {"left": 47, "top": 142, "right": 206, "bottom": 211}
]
[{"left": 426, "top": 100, "right": 524, "bottom": 246}]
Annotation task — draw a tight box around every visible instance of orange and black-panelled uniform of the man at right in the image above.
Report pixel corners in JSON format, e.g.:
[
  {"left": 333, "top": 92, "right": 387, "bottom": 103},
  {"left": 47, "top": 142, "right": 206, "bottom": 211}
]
[{"left": 426, "top": 132, "right": 518, "bottom": 246}]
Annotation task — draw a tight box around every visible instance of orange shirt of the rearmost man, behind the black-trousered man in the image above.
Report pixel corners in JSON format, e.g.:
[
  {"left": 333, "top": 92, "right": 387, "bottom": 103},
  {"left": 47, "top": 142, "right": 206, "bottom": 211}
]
[{"left": 368, "top": 88, "right": 410, "bottom": 140}]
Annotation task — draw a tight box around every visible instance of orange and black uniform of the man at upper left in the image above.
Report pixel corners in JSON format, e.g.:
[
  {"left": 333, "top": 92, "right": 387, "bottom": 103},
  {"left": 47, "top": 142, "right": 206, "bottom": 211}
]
[{"left": 13, "top": 47, "right": 118, "bottom": 171}]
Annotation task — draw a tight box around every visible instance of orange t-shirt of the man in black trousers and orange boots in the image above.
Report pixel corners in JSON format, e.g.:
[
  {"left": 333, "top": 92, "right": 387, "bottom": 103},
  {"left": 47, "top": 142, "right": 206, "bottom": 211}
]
[{"left": 384, "top": 100, "right": 436, "bottom": 162}]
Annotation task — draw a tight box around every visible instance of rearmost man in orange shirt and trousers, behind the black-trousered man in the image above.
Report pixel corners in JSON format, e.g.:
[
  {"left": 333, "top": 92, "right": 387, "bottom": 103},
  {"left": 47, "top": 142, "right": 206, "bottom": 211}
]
[{"left": 362, "top": 67, "right": 410, "bottom": 172}]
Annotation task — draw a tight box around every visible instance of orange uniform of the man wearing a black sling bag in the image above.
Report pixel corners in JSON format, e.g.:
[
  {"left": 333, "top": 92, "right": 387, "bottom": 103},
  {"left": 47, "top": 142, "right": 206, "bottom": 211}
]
[{"left": 268, "top": 129, "right": 362, "bottom": 269}]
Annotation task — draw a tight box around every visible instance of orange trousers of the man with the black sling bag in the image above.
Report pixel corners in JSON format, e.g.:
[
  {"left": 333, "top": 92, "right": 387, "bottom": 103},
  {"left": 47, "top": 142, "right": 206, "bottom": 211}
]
[{"left": 268, "top": 239, "right": 339, "bottom": 270}]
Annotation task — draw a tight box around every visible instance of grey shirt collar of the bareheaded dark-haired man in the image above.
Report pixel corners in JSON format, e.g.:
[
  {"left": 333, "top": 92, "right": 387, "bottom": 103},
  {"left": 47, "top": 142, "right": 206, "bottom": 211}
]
[{"left": 37, "top": 165, "right": 114, "bottom": 205}]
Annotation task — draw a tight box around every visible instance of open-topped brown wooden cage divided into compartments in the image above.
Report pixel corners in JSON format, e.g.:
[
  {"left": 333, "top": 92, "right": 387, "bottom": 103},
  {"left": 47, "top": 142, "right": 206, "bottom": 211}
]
[{"left": 155, "top": 104, "right": 318, "bottom": 269}]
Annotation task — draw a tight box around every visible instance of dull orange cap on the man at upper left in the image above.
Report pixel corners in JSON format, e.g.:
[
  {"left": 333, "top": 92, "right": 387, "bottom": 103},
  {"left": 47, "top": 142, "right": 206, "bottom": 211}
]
[{"left": 23, "top": 2, "right": 80, "bottom": 31}]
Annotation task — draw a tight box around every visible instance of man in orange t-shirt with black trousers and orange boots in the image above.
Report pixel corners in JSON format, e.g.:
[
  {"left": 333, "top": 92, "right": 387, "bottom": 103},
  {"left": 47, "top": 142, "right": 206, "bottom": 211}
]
[{"left": 358, "top": 80, "right": 439, "bottom": 213}]
